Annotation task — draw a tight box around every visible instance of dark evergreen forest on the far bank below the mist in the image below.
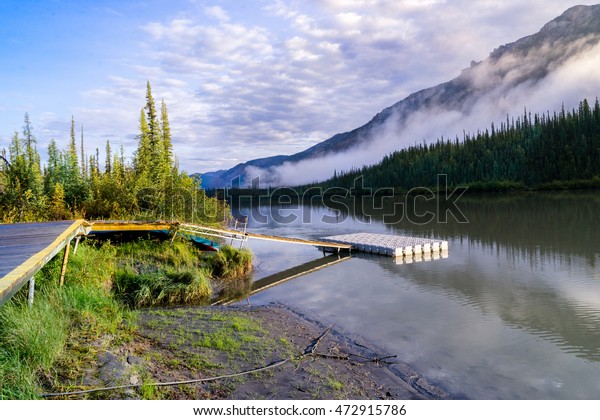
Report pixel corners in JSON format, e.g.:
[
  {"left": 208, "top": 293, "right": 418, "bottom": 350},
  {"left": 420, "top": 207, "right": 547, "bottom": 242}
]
[{"left": 320, "top": 99, "right": 600, "bottom": 192}]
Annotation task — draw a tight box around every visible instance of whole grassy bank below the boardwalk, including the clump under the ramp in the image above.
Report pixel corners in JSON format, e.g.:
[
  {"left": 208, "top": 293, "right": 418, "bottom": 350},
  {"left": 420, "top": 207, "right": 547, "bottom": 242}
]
[{"left": 0, "top": 241, "right": 252, "bottom": 399}]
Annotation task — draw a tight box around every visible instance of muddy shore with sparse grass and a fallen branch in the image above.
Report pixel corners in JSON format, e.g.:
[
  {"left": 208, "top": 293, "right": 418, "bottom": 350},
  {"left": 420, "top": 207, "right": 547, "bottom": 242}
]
[{"left": 48, "top": 303, "right": 451, "bottom": 400}]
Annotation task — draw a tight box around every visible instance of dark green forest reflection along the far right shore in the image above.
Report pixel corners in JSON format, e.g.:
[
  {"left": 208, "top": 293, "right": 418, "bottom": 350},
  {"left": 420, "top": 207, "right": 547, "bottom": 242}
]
[{"left": 332, "top": 193, "right": 600, "bottom": 265}]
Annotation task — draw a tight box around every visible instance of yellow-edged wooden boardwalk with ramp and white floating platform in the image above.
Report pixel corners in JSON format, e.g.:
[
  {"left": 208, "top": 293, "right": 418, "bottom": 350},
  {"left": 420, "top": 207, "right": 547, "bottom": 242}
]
[{"left": 0, "top": 220, "right": 448, "bottom": 306}]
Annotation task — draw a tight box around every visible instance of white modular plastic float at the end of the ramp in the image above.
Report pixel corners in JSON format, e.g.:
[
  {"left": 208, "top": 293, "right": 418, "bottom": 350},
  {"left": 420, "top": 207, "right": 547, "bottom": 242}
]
[{"left": 322, "top": 233, "right": 448, "bottom": 258}]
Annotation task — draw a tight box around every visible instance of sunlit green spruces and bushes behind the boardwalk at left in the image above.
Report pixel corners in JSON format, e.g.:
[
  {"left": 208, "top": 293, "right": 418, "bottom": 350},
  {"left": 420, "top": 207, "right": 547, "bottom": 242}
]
[{"left": 0, "top": 82, "right": 229, "bottom": 224}]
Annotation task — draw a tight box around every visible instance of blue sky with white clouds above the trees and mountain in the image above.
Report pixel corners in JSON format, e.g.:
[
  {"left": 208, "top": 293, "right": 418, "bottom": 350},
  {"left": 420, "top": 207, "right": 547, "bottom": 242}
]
[{"left": 0, "top": 0, "right": 595, "bottom": 173}]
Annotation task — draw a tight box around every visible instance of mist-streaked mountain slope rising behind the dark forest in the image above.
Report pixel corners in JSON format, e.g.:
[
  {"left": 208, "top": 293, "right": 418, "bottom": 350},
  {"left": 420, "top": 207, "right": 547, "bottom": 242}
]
[{"left": 201, "top": 5, "right": 600, "bottom": 188}]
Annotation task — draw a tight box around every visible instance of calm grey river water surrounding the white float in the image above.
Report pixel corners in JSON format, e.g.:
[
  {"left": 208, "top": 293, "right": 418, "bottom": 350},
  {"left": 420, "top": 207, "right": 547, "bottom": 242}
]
[{"left": 232, "top": 193, "right": 600, "bottom": 399}]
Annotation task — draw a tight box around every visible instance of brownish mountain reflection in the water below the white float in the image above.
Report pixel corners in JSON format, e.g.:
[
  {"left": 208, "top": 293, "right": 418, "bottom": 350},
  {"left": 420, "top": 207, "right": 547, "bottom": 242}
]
[{"left": 382, "top": 256, "right": 600, "bottom": 362}]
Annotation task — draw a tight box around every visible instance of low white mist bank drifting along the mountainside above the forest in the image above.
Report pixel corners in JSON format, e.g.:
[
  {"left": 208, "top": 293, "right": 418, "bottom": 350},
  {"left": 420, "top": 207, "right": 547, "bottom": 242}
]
[{"left": 246, "top": 37, "right": 600, "bottom": 186}]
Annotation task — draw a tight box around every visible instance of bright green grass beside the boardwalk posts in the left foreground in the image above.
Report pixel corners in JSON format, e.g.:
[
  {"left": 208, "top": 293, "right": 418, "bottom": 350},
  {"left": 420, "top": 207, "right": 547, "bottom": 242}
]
[{"left": 0, "top": 244, "right": 128, "bottom": 399}]
